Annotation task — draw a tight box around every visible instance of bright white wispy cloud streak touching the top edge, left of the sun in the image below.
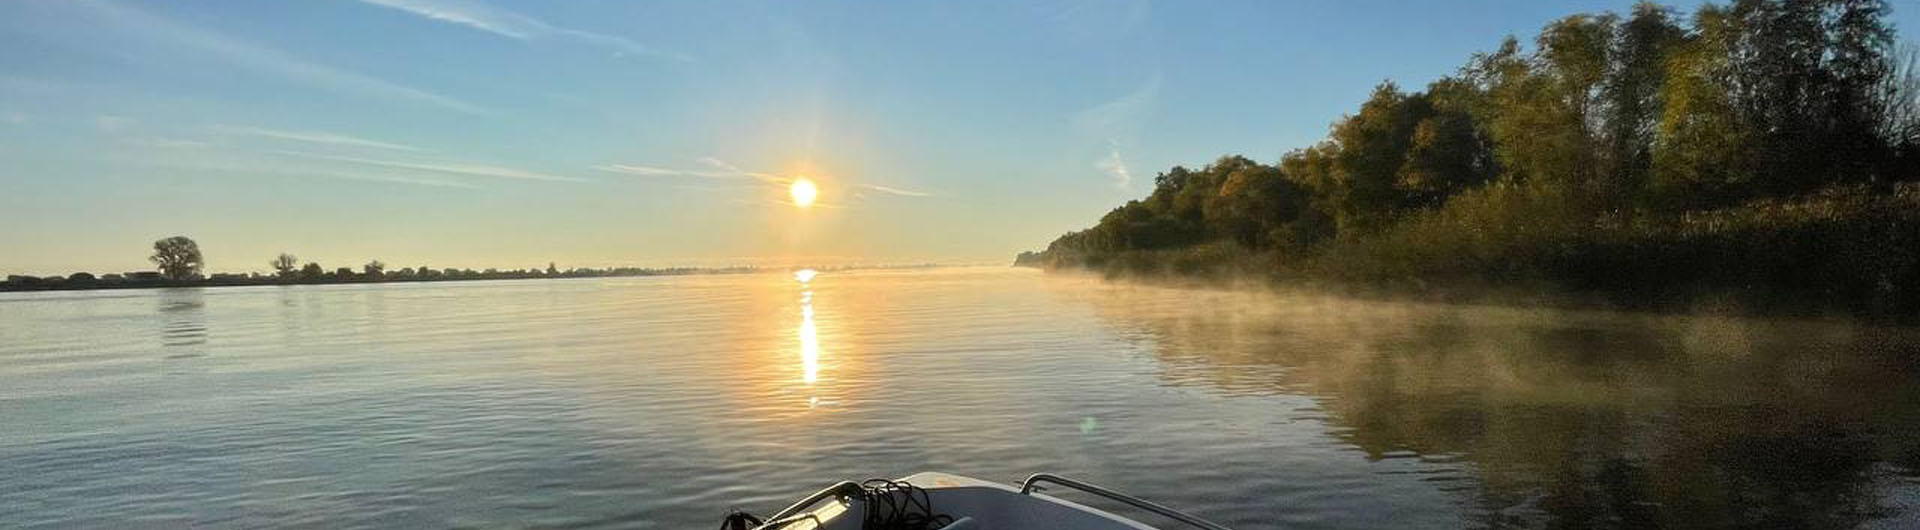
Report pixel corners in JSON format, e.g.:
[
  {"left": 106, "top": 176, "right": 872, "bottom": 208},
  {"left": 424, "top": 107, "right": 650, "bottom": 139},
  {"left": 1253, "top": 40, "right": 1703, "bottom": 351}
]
[{"left": 361, "top": 0, "right": 693, "bottom": 61}]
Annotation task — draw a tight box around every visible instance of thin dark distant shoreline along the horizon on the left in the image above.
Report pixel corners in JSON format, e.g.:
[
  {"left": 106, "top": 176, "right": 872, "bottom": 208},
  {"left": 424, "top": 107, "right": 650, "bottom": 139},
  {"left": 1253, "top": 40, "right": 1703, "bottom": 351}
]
[{"left": 0, "top": 263, "right": 945, "bottom": 292}]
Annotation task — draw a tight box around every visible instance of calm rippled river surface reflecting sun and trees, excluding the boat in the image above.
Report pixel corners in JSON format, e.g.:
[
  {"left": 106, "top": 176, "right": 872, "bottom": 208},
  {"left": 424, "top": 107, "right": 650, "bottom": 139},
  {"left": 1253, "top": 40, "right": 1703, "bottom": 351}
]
[{"left": 0, "top": 269, "right": 1920, "bottom": 528}]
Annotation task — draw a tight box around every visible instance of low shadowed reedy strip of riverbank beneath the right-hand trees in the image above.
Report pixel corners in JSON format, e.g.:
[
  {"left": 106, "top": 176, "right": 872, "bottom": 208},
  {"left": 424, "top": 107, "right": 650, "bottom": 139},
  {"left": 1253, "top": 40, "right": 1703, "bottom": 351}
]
[{"left": 1021, "top": 184, "right": 1920, "bottom": 319}]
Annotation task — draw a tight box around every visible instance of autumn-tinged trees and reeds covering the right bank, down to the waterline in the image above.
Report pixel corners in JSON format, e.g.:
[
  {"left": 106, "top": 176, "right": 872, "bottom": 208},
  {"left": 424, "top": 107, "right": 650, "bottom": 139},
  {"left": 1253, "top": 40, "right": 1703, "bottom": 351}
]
[{"left": 1016, "top": 0, "right": 1920, "bottom": 315}]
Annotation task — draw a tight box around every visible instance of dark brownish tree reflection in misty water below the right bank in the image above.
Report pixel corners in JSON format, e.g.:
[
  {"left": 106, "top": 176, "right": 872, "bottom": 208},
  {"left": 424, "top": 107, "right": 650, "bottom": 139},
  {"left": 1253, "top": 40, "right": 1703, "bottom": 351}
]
[{"left": 1089, "top": 288, "right": 1920, "bottom": 528}]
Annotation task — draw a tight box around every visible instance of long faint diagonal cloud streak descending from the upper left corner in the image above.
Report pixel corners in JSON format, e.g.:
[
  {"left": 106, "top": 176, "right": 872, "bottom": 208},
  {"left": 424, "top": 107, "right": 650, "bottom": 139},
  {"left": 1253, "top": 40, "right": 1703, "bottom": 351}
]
[{"left": 77, "top": 2, "right": 482, "bottom": 113}]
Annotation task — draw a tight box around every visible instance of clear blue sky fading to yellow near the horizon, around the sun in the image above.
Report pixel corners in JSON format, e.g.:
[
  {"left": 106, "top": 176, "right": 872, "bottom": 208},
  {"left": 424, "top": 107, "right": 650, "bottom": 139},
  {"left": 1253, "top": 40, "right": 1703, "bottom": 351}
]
[{"left": 0, "top": 0, "right": 1920, "bottom": 275}]
